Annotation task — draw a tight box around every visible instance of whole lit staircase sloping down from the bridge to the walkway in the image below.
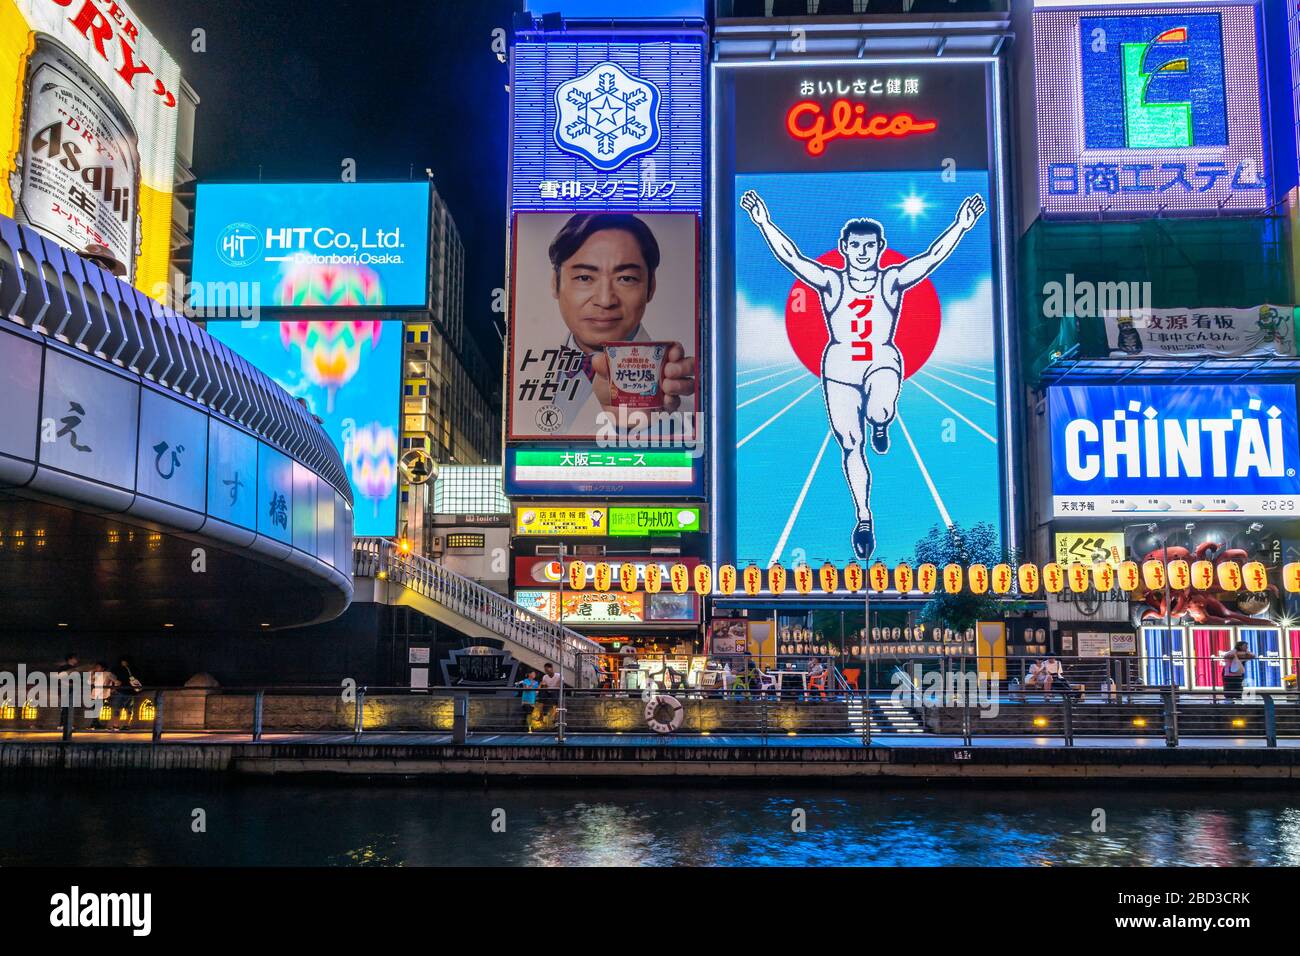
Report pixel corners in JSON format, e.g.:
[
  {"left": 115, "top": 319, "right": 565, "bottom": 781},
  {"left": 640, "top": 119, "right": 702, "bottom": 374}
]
[{"left": 352, "top": 537, "right": 601, "bottom": 687}]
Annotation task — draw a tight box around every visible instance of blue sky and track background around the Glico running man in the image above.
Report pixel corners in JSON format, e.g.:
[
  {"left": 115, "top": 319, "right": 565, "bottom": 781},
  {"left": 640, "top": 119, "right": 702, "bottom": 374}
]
[{"left": 732, "top": 169, "right": 1001, "bottom": 566}]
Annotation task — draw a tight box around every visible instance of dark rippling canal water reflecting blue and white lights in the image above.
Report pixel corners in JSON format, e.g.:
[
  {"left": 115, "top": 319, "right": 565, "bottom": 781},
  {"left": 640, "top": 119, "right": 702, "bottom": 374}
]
[{"left": 0, "top": 777, "right": 1300, "bottom": 866}]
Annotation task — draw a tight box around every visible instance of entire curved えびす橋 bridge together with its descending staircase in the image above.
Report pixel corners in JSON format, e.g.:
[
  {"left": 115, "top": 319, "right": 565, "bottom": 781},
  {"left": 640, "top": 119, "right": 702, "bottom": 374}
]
[{"left": 0, "top": 216, "right": 595, "bottom": 682}]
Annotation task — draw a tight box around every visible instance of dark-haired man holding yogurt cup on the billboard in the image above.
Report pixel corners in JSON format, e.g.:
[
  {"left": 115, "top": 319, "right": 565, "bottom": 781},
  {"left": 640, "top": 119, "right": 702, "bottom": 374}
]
[{"left": 549, "top": 213, "right": 696, "bottom": 432}]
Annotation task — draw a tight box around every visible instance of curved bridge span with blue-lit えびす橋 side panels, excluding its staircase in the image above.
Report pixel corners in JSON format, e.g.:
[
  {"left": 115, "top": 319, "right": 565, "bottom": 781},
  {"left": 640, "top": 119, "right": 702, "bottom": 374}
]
[{"left": 0, "top": 217, "right": 352, "bottom": 628}]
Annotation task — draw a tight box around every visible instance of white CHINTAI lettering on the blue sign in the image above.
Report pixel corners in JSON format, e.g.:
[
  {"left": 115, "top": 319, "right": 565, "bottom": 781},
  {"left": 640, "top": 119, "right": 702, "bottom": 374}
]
[{"left": 1062, "top": 398, "right": 1295, "bottom": 481}]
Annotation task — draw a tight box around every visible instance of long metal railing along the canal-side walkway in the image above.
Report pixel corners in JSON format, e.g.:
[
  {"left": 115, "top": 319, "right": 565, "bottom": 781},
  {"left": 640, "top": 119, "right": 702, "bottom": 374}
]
[{"left": 0, "top": 680, "right": 1300, "bottom": 748}]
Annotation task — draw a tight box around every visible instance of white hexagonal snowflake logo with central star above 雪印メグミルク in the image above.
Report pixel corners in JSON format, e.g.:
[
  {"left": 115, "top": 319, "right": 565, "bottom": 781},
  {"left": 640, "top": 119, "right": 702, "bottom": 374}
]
[{"left": 555, "top": 62, "right": 659, "bottom": 172}]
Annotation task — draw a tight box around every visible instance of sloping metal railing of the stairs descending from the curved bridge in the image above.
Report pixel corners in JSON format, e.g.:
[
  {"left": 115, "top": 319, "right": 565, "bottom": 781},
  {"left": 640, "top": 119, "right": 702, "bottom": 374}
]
[{"left": 352, "top": 537, "right": 601, "bottom": 687}]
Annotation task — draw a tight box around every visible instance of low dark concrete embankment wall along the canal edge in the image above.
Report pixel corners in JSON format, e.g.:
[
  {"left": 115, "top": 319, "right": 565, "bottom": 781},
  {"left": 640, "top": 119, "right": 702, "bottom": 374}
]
[{"left": 0, "top": 741, "right": 1300, "bottom": 787}]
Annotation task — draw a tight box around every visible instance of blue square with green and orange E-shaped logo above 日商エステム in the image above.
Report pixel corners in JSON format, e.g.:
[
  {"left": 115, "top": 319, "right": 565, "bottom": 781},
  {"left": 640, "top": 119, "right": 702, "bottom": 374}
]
[{"left": 1079, "top": 13, "right": 1227, "bottom": 150}]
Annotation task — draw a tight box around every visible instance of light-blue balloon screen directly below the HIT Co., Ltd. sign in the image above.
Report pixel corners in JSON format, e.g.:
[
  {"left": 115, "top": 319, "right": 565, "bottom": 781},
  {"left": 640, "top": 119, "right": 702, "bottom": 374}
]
[{"left": 208, "top": 319, "right": 402, "bottom": 537}]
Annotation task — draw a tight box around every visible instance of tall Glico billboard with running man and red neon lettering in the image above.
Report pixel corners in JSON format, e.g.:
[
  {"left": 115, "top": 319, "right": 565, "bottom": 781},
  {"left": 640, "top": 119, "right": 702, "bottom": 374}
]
[{"left": 712, "top": 57, "right": 1006, "bottom": 566}]
